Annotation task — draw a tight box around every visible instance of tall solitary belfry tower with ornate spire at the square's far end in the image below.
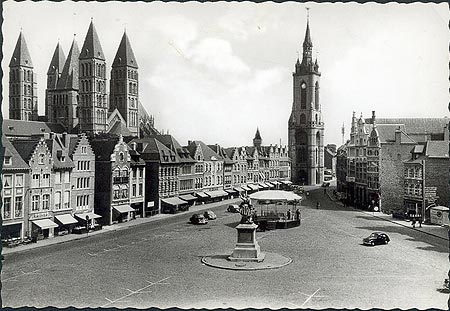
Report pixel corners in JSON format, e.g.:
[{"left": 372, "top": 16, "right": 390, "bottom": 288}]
[{"left": 288, "top": 18, "right": 324, "bottom": 185}]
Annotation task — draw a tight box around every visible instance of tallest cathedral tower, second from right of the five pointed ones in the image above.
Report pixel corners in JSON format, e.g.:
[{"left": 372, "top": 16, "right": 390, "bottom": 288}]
[{"left": 78, "top": 21, "right": 109, "bottom": 133}]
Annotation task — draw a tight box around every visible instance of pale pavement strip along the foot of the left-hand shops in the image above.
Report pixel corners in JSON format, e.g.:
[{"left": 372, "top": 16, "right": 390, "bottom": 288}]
[{"left": 1, "top": 198, "right": 240, "bottom": 256}]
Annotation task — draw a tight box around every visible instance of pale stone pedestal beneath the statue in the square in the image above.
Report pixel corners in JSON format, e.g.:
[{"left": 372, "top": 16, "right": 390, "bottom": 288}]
[{"left": 228, "top": 223, "right": 264, "bottom": 262}]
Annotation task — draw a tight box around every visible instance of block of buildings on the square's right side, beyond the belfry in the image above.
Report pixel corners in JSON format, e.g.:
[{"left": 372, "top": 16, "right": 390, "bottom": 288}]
[{"left": 336, "top": 111, "right": 450, "bottom": 220}]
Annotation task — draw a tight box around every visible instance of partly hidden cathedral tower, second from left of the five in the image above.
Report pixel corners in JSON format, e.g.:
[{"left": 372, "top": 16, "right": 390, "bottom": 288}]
[{"left": 45, "top": 42, "right": 66, "bottom": 123}]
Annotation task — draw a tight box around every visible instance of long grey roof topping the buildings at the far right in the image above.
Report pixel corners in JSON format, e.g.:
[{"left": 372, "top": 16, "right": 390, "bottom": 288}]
[{"left": 366, "top": 118, "right": 450, "bottom": 134}]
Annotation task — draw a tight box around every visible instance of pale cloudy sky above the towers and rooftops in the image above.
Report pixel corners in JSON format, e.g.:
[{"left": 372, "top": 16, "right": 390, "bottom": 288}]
[{"left": 2, "top": 1, "right": 449, "bottom": 146}]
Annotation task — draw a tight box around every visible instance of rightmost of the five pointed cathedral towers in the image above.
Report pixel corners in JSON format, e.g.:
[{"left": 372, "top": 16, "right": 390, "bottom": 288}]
[{"left": 110, "top": 32, "right": 139, "bottom": 136}]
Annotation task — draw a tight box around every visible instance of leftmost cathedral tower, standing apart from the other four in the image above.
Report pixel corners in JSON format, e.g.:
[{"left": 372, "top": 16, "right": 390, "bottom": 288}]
[{"left": 9, "top": 31, "right": 38, "bottom": 121}]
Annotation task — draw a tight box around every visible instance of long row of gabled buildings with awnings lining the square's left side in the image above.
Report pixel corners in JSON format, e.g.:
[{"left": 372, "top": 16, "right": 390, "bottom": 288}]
[{"left": 2, "top": 120, "right": 290, "bottom": 245}]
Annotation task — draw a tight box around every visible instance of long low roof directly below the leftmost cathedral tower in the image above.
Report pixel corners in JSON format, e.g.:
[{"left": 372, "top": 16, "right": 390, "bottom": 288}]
[{"left": 2, "top": 119, "right": 64, "bottom": 137}]
